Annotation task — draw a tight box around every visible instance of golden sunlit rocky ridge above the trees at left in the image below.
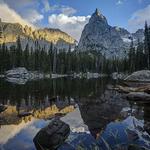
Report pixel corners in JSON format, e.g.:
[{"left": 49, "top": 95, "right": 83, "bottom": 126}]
[{"left": 0, "top": 20, "right": 76, "bottom": 49}]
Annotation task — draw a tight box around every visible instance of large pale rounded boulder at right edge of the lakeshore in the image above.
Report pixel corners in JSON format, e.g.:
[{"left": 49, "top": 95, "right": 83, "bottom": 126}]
[{"left": 125, "top": 70, "right": 150, "bottom": 82}]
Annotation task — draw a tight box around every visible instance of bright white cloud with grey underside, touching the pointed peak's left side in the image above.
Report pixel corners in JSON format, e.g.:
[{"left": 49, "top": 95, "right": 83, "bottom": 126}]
[{"left": 48, "top": 13, "right": 90, "bottom": 40}]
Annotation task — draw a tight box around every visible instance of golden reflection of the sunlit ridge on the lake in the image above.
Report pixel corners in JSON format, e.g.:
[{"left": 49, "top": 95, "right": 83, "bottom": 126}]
[{"left": 0, "top": 99, "right": 74, "bottom": 125}]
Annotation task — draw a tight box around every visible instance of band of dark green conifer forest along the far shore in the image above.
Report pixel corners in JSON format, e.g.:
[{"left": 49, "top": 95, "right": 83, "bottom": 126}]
[{"left": 0, "top": 23, "right": 150, "bottom": 74}]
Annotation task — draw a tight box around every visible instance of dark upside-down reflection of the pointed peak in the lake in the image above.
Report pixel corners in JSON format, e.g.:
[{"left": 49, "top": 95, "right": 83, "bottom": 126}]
[{"left": 79, "top": 90, "right": 128, "bottom": 137}]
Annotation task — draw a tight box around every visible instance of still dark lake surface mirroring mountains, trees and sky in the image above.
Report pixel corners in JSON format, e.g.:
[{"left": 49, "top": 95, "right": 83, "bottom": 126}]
[{"left": 0, "top": 78, "right": 150, "bottom": 150}]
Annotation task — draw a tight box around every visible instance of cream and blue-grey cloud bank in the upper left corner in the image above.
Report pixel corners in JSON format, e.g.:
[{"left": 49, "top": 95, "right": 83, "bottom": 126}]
[{"left": 0, "top": 0, "right": 44, "bottom": 27}]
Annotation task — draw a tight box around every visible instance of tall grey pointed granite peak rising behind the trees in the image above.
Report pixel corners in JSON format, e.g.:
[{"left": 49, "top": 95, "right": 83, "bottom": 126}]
[{"left": 78, "top": 9, "right": 144, "bottom": 57}]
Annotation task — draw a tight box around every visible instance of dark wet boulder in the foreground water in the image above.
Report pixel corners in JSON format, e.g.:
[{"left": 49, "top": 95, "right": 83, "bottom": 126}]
[{"left": 33, "top": 118, "right": 70, "bottom": 150}]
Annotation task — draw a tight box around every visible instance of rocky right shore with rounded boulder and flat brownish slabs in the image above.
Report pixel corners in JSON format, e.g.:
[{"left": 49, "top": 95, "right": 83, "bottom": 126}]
[{"left": 112, "top": 70, "right": 150, "bottom": 103}]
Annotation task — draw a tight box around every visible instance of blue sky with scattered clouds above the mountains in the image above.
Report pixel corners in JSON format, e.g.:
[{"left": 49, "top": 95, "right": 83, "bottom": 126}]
[{"left": 0, "top": 0, "right": 150, "bottom": 40}]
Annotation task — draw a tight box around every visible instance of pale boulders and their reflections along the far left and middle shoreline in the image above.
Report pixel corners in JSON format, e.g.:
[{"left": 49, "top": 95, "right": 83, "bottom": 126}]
[{"left": 0, "top": 67, "right": 108, "bottom": 84}]
